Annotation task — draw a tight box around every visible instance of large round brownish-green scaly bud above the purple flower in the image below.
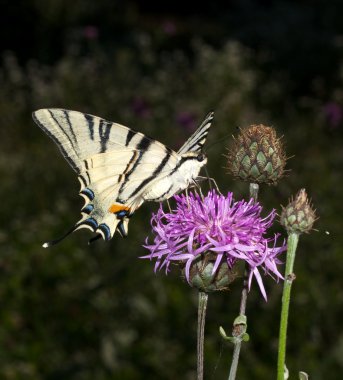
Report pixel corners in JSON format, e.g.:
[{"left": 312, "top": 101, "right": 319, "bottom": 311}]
[{"left": 227, "top": 124, "right": 287, "bottom": 185}]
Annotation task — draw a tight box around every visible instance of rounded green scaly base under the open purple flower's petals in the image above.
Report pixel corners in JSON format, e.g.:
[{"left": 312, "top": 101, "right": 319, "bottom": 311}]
[{"left": 183, "top": 252, "right": 238, "bottom": 293}]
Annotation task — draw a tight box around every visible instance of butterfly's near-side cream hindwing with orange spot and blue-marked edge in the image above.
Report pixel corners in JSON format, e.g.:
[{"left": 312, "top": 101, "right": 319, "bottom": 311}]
[{"left": 77, "top": 145, "right": 178, "bottom": 240}]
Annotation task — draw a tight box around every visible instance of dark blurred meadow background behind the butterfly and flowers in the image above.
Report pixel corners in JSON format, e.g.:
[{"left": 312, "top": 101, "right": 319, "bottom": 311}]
[{"left": 0, "top": 0, "right": 343, "bottom": 380}]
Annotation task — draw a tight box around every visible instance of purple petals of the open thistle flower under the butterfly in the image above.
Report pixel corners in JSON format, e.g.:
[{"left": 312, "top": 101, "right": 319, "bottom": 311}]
[{"left": 142, "top": 191, "right": 286, "bottom": 299}]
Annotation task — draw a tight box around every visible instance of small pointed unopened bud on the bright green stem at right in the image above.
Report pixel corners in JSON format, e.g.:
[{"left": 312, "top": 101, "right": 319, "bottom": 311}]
[{"left": 280, "top": 189, "right": 317, "bottom": 234}]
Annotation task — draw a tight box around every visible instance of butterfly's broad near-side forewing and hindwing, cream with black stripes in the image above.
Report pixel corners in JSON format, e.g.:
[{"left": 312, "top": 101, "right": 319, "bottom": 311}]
[{"left": 33, "top": 109, "right": 178, "bottom": 246}]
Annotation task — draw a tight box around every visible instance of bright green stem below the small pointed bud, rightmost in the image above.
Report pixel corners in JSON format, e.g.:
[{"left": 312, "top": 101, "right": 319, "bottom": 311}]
[{"left": 277, "top": 233, "right": 299, "bottom": 380}]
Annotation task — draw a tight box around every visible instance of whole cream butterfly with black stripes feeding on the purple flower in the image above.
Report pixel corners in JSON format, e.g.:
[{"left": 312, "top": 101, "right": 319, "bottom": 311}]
[{"left": 32, "top": 108, "right": 214, "bottom": 248}]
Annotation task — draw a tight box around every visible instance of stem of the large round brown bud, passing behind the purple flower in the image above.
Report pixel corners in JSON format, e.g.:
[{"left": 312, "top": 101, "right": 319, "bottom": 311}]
[{"left": 229, "top": 183, "right": 259, "bottom": 380}]
